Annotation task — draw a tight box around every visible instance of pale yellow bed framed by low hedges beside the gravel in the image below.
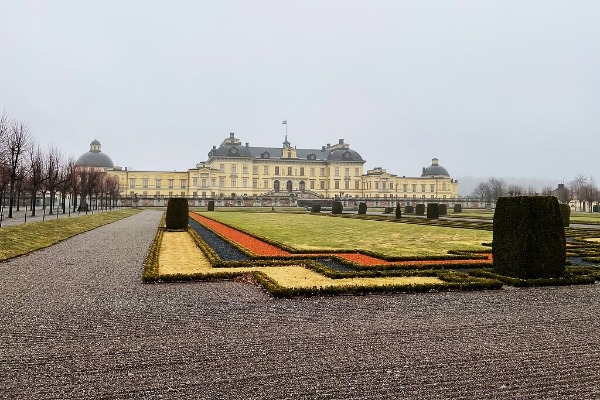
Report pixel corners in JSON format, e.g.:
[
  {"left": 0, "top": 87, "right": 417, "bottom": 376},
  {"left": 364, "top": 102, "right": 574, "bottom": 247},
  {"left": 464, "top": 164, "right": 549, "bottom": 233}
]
[{"left": 158, "top": 232, "right": 443, "bottom": 288}]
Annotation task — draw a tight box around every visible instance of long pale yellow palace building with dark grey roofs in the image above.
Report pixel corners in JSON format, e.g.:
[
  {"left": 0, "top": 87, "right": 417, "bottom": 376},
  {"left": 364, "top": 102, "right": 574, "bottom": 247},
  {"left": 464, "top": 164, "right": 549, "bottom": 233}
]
[{"left": 96, "top": 132, "right": 458, "bottom": 203}]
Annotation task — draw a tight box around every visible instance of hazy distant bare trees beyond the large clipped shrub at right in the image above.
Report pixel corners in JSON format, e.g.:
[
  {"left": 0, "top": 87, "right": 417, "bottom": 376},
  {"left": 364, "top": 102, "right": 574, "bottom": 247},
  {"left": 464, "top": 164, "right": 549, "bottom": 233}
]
[{"left": 472, "top": 174, "right": 600, "bottom": 211}]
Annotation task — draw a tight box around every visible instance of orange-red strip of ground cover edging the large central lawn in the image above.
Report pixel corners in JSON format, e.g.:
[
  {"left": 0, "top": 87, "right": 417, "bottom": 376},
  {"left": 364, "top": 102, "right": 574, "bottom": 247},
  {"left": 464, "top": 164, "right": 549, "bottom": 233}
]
[{"left": 190, "top": 212, "right": 492, "bottom": 266}]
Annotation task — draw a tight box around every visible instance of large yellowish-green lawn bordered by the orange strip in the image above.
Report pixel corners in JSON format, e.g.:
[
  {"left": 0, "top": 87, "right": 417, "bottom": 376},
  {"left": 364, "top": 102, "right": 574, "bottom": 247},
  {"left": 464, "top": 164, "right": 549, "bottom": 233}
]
[{"left": 202, "top": 211, "right": 492, "bottom": 256}]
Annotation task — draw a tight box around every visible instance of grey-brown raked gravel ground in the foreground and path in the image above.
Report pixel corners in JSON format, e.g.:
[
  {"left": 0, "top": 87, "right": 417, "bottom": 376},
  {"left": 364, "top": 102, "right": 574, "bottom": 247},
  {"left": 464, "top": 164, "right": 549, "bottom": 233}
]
[{"left": 0, "top": 211, "right": 600, "bottom": 399}]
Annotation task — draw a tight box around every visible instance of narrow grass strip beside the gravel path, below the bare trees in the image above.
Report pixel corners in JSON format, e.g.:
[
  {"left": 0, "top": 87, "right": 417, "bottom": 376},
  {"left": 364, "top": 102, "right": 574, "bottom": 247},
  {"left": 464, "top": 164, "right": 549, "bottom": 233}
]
[{"left": 0, "top": 209, "right": 140, "bottom": 261}]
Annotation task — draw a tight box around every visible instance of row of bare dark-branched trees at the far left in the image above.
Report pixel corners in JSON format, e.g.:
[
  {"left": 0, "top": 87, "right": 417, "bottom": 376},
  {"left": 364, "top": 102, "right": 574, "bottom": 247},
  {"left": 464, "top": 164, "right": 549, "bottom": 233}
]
[{"left": 0, "top": 112, "right": 119, "bottom": 218}]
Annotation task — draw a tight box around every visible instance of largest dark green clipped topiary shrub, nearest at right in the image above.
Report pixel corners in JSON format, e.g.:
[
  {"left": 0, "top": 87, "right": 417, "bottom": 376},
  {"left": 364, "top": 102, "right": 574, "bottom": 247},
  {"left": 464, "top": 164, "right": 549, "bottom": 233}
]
[{"left": 492, "top": 196, "right": 566, "bottom": 279}]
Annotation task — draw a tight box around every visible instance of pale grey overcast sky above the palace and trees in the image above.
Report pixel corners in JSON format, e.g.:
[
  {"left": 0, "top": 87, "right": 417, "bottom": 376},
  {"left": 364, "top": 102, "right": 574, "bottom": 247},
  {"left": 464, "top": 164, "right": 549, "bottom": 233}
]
[{"left": 0, "top": 0, "right": 600, "bottom": 191}]
